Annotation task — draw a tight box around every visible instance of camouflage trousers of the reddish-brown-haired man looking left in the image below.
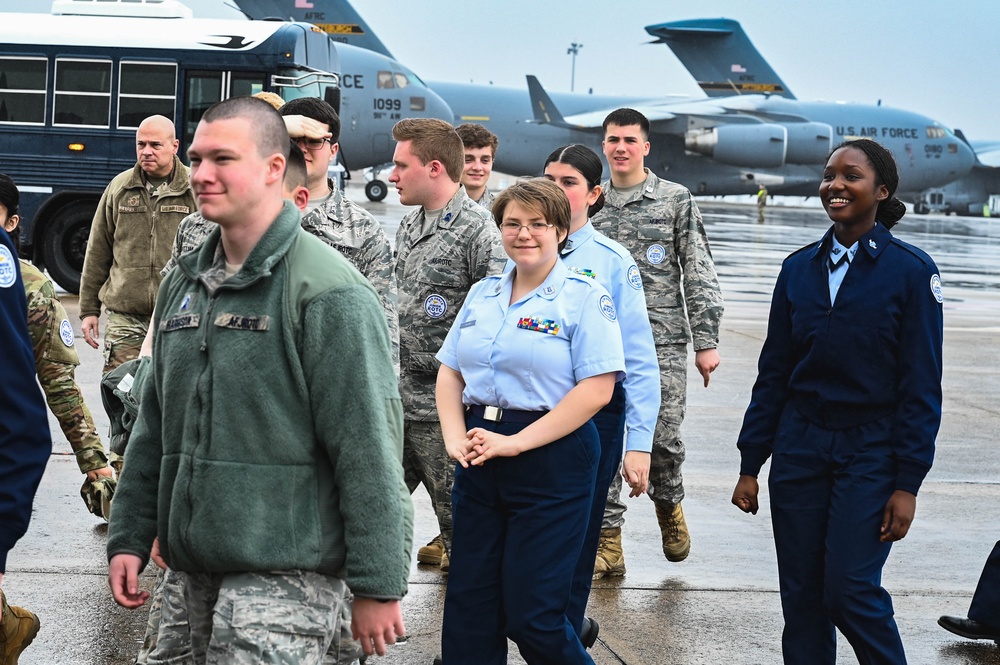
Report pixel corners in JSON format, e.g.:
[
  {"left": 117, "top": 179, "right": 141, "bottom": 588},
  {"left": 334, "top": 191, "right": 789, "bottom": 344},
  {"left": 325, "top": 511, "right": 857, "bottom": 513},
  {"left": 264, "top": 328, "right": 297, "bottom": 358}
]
[{"left": 403, "top": 420, "right": 455, "bottom": 551}]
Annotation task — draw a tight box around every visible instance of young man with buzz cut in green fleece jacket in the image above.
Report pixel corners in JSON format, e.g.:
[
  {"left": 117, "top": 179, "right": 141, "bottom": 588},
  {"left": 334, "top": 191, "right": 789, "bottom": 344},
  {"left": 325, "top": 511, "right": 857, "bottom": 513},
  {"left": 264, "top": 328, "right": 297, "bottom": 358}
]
[{"left": 108, "top": 97, "right": 413, "bottom": 664}]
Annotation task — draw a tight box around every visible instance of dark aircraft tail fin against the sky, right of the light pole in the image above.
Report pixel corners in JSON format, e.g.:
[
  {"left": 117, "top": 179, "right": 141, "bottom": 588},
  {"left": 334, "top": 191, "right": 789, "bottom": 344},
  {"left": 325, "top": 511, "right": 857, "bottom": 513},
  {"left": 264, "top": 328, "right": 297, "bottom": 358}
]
[{"left": 646, "top": 18, "right": 795, "bottom": 99}]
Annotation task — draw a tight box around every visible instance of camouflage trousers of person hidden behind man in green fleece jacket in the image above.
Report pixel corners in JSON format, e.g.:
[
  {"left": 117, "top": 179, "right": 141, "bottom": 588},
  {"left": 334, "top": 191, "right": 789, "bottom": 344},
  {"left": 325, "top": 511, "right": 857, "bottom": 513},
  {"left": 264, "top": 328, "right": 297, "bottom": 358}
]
[{"left": 135, "top": 570, "right": 364, "bottom": 665}]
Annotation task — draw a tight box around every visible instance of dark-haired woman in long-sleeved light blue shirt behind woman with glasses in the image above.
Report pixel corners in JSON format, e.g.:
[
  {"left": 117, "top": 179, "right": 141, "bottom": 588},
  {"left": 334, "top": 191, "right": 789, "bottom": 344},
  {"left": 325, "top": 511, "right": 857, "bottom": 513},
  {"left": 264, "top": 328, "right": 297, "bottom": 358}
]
[{"left": 545, "top": 145, "right": 660, "bottom": 632}]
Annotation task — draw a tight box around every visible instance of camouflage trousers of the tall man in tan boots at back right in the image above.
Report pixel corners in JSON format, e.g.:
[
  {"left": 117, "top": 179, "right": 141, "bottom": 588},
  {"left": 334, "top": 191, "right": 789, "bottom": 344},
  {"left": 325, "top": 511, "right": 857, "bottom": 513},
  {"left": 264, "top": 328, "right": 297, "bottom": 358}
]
[{"left": 601, "top": 344, "right": 688, "bottom": 529}]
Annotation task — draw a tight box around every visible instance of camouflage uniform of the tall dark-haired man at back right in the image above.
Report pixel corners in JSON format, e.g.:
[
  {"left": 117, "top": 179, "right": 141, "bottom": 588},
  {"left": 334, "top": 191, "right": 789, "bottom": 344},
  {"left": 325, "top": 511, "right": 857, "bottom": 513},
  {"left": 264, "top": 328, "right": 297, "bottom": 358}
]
[{"left": 593, "top": 169, "right": 723, "bottom": 529}]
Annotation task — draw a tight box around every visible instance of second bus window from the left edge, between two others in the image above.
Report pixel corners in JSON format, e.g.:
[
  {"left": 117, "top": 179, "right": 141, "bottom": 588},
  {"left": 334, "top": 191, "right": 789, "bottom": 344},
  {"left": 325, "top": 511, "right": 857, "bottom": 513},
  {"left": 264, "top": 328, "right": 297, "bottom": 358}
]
[{"left": 52, "top": 58, "right": 111, "bottom": 127}]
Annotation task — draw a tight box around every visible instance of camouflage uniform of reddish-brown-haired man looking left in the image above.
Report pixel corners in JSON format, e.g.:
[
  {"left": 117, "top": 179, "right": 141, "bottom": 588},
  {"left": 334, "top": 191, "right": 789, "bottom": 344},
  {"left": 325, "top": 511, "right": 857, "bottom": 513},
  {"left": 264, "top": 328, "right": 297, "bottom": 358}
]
[{"left": 396, "top": 187, "right": 507, "bottom": 548}]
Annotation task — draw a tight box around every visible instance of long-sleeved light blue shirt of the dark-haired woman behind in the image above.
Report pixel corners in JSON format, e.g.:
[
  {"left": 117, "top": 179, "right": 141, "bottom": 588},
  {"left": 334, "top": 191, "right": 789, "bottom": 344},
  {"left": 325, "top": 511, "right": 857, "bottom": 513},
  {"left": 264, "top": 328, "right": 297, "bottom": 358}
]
[{"left": 560, "top": 221, "right": 660, "bottom": 453}]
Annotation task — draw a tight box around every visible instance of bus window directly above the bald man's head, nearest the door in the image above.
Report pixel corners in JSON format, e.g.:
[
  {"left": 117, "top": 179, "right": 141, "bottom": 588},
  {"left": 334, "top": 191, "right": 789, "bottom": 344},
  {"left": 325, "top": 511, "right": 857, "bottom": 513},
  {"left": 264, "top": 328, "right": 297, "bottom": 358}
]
[{"left": 118, "top": 61, "right": 177, "bottom": 129}]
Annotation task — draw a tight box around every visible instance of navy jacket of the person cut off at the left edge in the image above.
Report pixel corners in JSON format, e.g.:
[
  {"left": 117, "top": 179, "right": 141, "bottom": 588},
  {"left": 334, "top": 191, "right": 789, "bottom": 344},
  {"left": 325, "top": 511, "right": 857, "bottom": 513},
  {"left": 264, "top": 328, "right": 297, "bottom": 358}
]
[{"left": 0, "top": 228, "right": 52, "bottom": 573}]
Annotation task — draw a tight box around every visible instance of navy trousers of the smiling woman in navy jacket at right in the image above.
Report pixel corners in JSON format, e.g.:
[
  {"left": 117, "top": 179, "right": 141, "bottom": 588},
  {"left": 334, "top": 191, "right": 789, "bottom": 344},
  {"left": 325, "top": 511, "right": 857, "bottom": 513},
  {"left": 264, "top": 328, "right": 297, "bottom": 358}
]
[{"left": 768, "top": 406, "right": 906, "bottom": 665}]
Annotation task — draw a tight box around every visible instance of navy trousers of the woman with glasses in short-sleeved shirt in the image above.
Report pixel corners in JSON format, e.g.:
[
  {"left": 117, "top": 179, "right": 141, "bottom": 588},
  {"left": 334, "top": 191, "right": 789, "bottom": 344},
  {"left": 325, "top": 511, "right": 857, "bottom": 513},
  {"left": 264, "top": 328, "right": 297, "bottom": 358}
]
[{"left": 441, "top": 415, "right": 600, "bottom": 665}]
